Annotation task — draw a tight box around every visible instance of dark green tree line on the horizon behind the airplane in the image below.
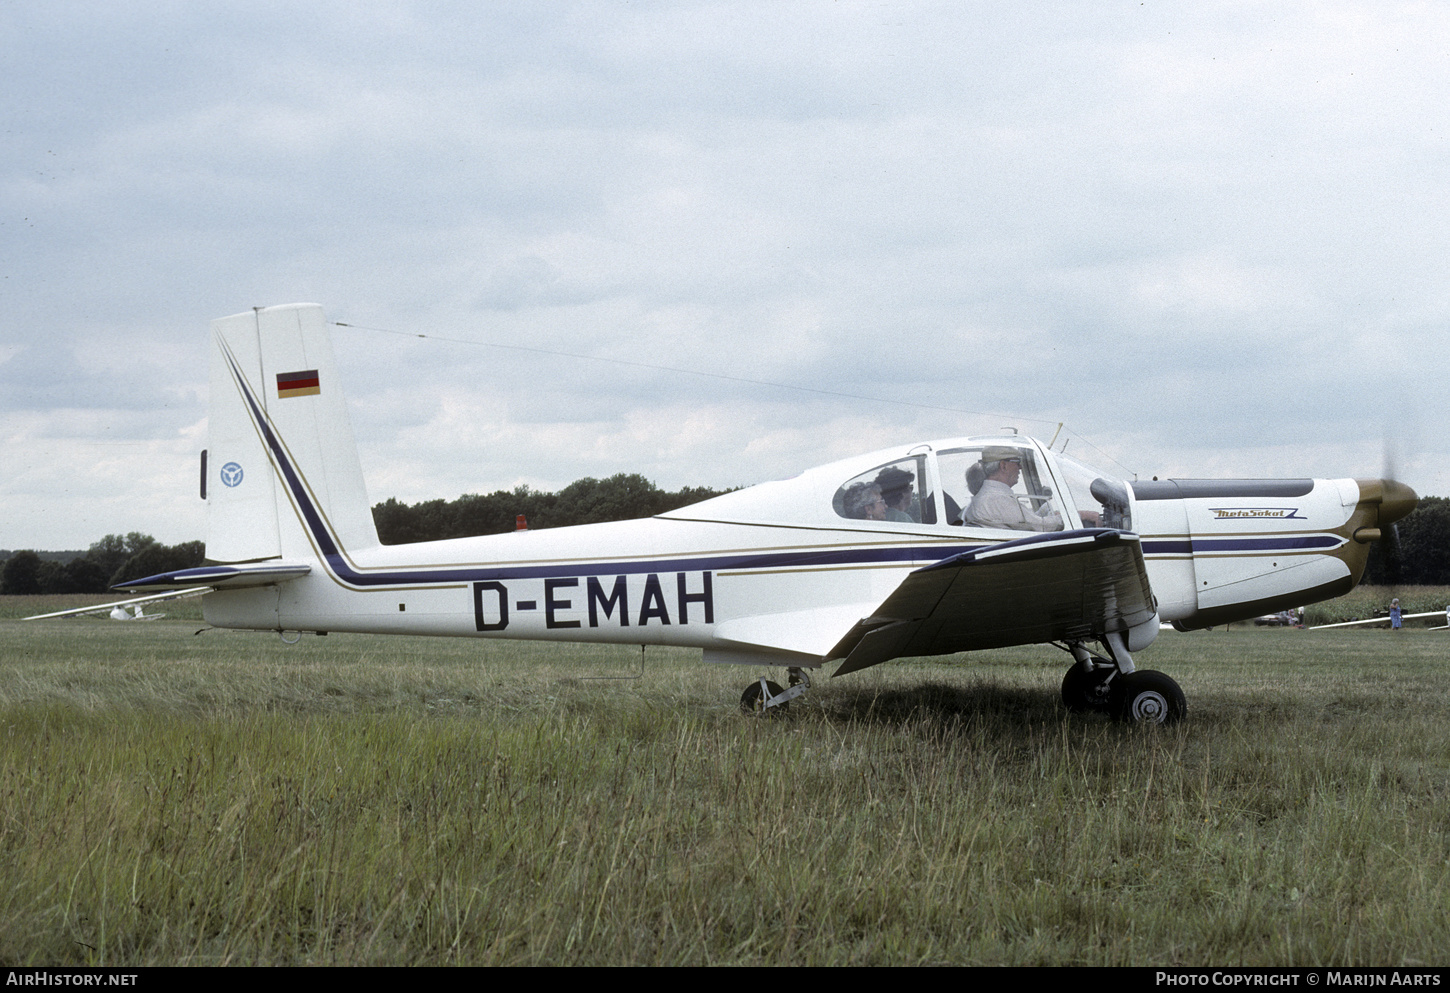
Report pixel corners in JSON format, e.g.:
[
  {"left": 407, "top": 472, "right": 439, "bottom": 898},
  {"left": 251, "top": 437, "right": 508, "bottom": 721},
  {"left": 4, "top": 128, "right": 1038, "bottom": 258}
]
[{"left": 8, "top": 484, "right": 1450, "bottom": 594}]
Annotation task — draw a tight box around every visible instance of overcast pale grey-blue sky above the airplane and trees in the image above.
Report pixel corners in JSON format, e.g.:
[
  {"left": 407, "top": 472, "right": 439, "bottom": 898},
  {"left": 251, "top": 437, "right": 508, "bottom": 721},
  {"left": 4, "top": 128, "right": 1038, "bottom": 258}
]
[{"left": 0, "top": 0, "right": 1450, "bottom": 548}]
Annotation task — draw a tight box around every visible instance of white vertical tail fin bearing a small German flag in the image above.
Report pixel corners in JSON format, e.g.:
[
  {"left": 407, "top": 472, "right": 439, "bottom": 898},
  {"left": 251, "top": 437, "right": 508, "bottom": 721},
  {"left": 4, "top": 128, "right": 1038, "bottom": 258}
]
[{"left": 206, "top": 303, "right": 378, "bottom": 562}]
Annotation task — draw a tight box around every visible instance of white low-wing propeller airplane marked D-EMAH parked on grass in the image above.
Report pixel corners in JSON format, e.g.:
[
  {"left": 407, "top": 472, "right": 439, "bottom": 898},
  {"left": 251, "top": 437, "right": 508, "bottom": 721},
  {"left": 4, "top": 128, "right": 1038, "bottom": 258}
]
[{"left": 31, "top": 304, "right": 1417, "bottom": 722}]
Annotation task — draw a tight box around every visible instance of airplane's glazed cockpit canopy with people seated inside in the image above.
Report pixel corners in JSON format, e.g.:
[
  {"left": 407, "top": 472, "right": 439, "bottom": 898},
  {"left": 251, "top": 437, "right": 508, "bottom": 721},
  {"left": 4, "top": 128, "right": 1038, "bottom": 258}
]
[{"left": 666, "top": 436, "right": 1132, "bottom": 532}]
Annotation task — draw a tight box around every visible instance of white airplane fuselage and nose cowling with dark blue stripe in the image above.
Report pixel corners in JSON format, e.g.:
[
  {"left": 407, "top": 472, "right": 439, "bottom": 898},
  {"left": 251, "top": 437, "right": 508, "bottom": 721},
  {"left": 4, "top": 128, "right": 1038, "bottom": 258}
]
[{"left": 206, "top": 438, "right": 1367, "bottom": 665}]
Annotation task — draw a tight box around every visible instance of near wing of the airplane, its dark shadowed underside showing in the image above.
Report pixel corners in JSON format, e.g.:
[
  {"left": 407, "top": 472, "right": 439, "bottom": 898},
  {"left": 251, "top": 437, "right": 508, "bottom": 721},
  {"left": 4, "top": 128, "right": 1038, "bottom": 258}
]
[{"left": 825, "top": 528, "right": 1157, "bottom": 676}]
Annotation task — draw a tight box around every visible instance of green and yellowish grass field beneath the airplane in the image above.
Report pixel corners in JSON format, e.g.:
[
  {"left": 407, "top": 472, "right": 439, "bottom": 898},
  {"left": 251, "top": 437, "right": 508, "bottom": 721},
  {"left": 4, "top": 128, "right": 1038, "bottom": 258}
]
[{"left": 0, "top": 607, "right": 1450, "bottom": 965}]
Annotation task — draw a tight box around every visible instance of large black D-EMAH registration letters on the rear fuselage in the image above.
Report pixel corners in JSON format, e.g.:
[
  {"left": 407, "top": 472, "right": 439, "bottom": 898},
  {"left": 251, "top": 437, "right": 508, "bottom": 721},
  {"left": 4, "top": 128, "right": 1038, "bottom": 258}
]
[{"left": 473, "top": 573, "right": 715, "bottom": 631}]
